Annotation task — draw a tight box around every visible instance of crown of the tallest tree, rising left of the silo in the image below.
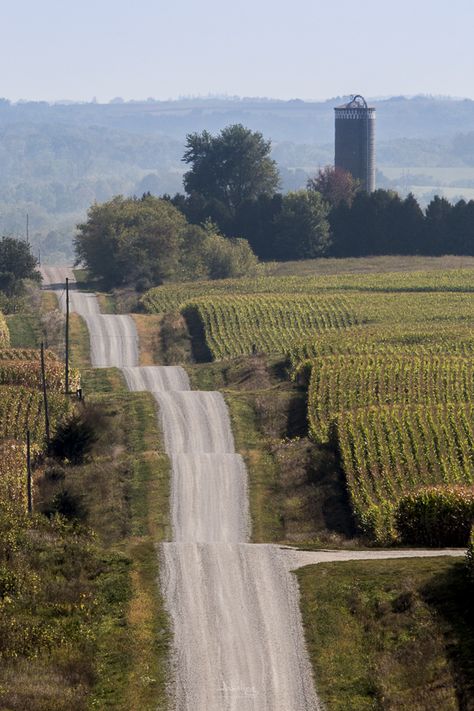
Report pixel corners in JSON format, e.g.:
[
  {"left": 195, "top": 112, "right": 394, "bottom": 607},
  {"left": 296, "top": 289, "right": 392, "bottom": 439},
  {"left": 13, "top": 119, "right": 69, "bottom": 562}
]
[{"left": 183, "top": 124, "right": 279, "bottom": 216}]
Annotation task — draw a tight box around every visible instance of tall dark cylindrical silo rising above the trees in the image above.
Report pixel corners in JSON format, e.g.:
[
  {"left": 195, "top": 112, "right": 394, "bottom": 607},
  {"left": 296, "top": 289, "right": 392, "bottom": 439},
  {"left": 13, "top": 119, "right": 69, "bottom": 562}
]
[{"left": 334, "top": 94, "right": 375, "bottom": 193}]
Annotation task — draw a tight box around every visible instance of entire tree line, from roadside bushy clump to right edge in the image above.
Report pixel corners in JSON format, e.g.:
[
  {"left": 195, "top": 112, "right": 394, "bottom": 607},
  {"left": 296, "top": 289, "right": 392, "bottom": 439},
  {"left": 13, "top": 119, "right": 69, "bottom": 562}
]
[{"left": 75, "top": 124, "right": 474, "bottom": 290}]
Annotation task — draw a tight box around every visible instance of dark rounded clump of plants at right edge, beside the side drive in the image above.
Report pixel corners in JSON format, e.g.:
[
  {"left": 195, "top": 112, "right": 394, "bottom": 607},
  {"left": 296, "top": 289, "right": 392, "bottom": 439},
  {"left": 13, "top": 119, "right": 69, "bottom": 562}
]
[{"left": 395, "top": 486, "right": 474, "bottom": 546}]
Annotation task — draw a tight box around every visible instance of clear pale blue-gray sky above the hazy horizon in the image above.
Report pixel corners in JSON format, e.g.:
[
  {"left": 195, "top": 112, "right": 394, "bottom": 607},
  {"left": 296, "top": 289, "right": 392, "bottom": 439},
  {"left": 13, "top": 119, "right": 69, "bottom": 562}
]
[{"left": 0, "top": 0, "right": 474, "bottom": 101}]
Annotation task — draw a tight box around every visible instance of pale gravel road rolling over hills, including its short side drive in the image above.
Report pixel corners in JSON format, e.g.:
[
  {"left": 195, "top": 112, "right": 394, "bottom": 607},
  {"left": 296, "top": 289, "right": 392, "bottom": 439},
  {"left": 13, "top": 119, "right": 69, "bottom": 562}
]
[{"left": 39, "top": 267, "right": 459, "bottom": 711}]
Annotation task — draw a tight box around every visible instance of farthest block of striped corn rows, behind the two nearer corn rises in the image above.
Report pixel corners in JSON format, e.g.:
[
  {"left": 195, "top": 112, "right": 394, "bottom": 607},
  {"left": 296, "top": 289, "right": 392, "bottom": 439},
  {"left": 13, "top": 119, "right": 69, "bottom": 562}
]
[{"left": 182, "top": 286, "right": 474, "bottom": 362}]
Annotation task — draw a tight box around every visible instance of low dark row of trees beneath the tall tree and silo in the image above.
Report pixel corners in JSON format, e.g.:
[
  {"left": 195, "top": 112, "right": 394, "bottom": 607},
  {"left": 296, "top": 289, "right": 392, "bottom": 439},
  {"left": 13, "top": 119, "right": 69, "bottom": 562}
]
[{"left": 173, "top": 188, "right": 474, "bottom": 260}]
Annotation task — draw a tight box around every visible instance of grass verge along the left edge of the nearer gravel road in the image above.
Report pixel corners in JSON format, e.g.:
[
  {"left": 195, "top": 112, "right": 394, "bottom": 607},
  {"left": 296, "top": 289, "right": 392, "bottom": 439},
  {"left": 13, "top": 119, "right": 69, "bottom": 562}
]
[{"left": 83, "top": 390, "right": 170, "bottom": 711}]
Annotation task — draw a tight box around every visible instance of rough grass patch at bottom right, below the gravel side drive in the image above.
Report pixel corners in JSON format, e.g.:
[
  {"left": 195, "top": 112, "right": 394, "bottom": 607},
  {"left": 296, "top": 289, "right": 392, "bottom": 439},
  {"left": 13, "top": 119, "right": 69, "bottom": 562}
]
[{"left": 296, "top": 558, "right": 474, "bottom": 711}]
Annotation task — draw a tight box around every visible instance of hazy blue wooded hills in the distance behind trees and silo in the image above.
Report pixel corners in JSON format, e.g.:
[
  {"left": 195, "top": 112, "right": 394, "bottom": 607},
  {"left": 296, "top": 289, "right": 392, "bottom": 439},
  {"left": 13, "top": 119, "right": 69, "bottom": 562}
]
[{"left": 0, "top": 97, "right": 474, "bottom": 260}]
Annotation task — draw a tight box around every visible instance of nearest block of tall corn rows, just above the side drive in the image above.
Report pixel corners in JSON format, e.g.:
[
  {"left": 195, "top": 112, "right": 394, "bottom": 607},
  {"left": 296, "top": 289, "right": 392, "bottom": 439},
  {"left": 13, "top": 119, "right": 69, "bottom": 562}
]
[{"left": 334, "top": 405, "right": 474, "bottom": 543}]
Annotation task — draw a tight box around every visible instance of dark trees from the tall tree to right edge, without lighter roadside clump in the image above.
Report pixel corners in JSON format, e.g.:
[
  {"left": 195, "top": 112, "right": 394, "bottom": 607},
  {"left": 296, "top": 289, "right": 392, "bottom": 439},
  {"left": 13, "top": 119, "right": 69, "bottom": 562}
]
[{"left": 169, "top": 125, "right": 474, "bottom": 260}]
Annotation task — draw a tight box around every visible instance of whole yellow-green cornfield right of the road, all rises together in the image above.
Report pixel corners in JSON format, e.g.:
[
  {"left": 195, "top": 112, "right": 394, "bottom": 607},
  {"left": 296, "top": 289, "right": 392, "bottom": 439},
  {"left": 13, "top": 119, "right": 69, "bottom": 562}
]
[{"left": 143, "top": 260, "right": 474, "bottom": 542}]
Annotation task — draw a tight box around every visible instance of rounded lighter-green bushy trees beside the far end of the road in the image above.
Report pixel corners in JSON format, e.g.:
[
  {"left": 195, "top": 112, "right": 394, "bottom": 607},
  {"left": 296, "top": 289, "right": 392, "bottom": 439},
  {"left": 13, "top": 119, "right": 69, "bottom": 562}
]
[{"left": 75, "top": 195, "right": 257, "bottom": 291}]
